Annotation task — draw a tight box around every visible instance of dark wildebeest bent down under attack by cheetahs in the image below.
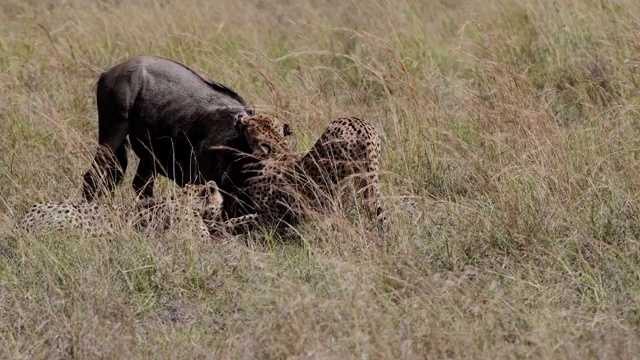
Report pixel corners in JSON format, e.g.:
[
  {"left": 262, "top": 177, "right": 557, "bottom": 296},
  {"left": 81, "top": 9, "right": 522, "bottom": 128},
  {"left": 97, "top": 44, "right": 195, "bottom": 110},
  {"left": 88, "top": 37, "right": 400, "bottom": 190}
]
[{"left": 83, "top": 56, "right": 291, "bottom": 214}]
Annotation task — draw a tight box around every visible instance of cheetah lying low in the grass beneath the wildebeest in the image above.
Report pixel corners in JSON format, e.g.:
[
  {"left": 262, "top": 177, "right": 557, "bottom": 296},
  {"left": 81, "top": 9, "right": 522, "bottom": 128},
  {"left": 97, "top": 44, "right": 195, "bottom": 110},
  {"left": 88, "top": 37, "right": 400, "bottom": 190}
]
[{"left": 19, "top": 181, "right": 222, "bottom": 240}]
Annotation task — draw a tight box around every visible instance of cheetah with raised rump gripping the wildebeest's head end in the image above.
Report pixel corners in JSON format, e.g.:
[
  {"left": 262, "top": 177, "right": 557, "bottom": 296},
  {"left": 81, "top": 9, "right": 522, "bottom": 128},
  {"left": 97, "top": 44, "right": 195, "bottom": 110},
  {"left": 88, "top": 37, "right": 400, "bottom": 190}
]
[{"left": 234, "top": 117, "right": 386, "bottom": 231}]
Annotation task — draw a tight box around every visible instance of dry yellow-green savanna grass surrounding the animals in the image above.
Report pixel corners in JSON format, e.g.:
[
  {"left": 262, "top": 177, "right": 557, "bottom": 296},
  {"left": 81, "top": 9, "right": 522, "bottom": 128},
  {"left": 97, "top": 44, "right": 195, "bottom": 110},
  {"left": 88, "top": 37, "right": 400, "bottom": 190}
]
[{"left": 0, "top": 0, "right": 640, "bottom": 359}]
